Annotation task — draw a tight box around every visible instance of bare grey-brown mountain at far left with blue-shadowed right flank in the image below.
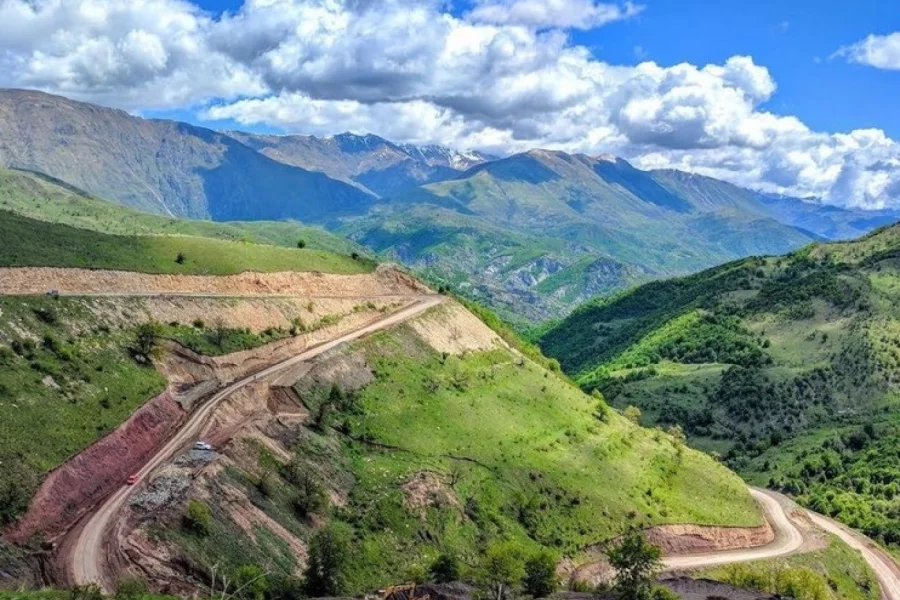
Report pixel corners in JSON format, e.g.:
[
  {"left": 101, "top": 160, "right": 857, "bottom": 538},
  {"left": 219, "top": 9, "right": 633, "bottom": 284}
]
[{"left": 0, "top": 90, "right": 375, "bottom": 221}]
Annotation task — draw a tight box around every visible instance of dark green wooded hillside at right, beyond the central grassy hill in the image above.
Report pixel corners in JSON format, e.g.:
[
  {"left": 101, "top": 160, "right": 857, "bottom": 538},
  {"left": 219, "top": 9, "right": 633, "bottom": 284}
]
[{"left": 539, "top": 221, "right": 900, "bottom": 544}]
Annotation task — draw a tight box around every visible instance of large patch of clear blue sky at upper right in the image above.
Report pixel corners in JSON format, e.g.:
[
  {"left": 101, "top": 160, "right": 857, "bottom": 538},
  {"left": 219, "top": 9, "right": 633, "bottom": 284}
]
[{"left": 573, "top": 0, "right": 900, "bottom": 138}]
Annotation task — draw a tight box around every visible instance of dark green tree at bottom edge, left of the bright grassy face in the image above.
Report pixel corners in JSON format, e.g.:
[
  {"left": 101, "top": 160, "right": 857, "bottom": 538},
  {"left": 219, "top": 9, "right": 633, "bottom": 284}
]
[{"left": 305, "top": 523, "right": 350, "bottom": 598}]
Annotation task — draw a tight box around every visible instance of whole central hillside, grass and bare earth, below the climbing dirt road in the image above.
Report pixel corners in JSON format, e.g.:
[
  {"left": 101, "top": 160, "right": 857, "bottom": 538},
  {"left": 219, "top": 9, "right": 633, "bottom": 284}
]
[{"left": 77, "top": 303, "right": 761, "bottom": 593}]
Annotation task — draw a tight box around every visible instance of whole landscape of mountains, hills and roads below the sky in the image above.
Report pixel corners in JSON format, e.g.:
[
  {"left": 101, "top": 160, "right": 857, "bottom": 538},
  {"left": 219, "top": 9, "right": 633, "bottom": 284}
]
[{"left": 0, "top": 85, "right": 900, "bottom": 600}]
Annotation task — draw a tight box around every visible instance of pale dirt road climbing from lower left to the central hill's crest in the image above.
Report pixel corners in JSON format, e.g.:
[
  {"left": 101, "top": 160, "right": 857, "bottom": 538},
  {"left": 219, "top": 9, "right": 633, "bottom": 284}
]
[{"left": 67, "top": 296, "right": 444, "bottom": 592}]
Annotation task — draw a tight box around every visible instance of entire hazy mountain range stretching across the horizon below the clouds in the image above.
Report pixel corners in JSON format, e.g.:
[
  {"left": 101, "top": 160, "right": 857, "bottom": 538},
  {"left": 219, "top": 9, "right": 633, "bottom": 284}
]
[{"left": 0, "top": 90, "right": 897, "bottom": 323}]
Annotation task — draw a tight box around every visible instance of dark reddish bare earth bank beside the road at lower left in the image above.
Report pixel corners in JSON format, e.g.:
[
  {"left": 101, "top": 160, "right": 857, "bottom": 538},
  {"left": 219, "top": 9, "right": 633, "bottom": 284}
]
[{"left": 8, "top": 391, "right": 187, "bottom": 542}]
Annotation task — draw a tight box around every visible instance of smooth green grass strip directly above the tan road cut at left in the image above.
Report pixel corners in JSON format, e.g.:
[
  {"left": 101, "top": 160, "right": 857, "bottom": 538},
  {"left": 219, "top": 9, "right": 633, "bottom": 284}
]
[{"left": 0, "top": 212, "right": 373, "bottom": 275}]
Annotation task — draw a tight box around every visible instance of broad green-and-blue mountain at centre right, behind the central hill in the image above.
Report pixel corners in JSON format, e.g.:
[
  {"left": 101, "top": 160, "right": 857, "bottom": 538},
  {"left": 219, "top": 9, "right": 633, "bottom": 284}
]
[{"left": 343, "top": 150, "right": 832, "bottom": 320}]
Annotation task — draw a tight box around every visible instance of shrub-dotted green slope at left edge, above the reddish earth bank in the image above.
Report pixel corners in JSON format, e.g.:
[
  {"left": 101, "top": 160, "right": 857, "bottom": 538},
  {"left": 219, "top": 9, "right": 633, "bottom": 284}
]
[{"left": 0, "top": 297, "right": 165, "bottom": 523}]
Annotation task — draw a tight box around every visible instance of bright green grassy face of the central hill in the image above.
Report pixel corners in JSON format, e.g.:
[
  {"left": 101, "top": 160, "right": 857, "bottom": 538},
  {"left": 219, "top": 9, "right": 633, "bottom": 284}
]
[{"left": 155, "top": 308, "right": 760, "bottom": 593}]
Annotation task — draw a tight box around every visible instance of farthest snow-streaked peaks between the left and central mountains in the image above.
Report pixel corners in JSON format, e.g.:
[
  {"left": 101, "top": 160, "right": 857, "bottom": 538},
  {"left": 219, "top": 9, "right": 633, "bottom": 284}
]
[{"left": 229, "top": 132, "right": 496, "bottom": 196}]
